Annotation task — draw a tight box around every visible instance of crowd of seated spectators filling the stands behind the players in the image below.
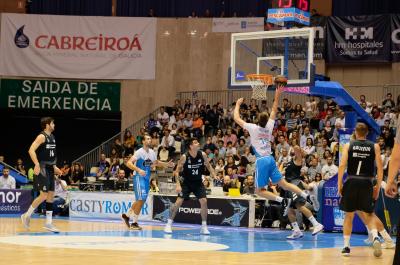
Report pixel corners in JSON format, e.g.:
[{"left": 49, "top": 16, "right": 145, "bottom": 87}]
[{"left": 1, "top": 93, "right": 400, "bottom": 225}]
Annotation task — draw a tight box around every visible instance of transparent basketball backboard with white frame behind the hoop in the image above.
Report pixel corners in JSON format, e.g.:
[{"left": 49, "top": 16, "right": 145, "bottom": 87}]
[{"left": 228, "top": 28, "right": 314, "bottom": 88}]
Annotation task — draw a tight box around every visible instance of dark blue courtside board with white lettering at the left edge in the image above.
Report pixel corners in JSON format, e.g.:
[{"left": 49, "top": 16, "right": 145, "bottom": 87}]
[{"left": 0, "top": 190, "right": 32, "bottom": 214}]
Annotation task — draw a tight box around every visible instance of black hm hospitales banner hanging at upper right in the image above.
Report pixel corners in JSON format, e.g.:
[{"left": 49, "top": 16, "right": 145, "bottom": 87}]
[{"left": 326, "top": 15, "right": 391, "bottom": 63}]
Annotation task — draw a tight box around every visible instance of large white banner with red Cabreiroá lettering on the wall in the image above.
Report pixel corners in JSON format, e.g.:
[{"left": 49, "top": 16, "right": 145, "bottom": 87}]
[{"left": 0, "top": 14, "right": 157, "bottom": 79}]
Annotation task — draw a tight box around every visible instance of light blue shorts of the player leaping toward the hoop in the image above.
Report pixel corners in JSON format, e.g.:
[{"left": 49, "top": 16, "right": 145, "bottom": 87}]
[{"left": 254, "top": 156, "right": 282, "bottom": 188}]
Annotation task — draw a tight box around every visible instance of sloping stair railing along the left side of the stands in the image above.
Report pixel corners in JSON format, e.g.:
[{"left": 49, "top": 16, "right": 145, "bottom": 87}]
[{"left": 72, "top": 108, "right": 160, "bottom": 174}]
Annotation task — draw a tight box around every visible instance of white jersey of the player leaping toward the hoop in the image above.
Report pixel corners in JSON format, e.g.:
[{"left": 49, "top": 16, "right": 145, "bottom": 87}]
[{"left": 243, "top": 119, "right": 275, "bottom": 158}]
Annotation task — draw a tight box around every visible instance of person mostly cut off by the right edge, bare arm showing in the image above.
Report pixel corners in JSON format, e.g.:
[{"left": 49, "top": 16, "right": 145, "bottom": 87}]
[{"left": 385, "top": 121, "right": 400, "bottom": 265}]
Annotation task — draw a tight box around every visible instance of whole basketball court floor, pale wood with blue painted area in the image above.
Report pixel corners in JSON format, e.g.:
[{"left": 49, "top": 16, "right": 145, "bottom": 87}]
[{"left": 0, "top": 216, "right": 394, "bottom": 265}]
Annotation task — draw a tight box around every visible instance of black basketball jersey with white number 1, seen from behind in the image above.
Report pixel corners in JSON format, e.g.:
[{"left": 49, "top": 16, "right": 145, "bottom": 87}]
[{"left": 347, "top": 140, "right": 375, "bottom": 177}]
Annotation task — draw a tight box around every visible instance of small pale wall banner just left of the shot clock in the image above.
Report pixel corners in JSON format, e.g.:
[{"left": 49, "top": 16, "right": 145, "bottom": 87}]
[{"left": 212, "top": 17, "right": 264, "bottom": 32}]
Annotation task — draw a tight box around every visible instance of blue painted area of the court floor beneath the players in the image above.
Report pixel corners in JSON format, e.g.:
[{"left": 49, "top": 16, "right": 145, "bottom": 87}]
[{"left": 14, "top": 220, "right": 376, "bottom": 253}]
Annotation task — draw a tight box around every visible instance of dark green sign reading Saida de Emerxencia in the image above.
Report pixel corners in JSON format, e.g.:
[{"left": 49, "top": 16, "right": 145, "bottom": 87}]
[{"left": 0, "top": 79, "right": 121, "bottom": 112}]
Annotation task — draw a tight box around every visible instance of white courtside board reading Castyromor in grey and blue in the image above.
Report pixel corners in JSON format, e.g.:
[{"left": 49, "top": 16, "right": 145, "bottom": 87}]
[{"left": 69, "top": 191, "right": 153, "bottom": 220}]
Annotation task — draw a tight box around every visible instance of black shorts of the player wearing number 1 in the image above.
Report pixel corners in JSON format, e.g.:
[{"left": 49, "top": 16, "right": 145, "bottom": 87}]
[{"left": 340, "top": 177, "right": 375, "bottom": 213}]
